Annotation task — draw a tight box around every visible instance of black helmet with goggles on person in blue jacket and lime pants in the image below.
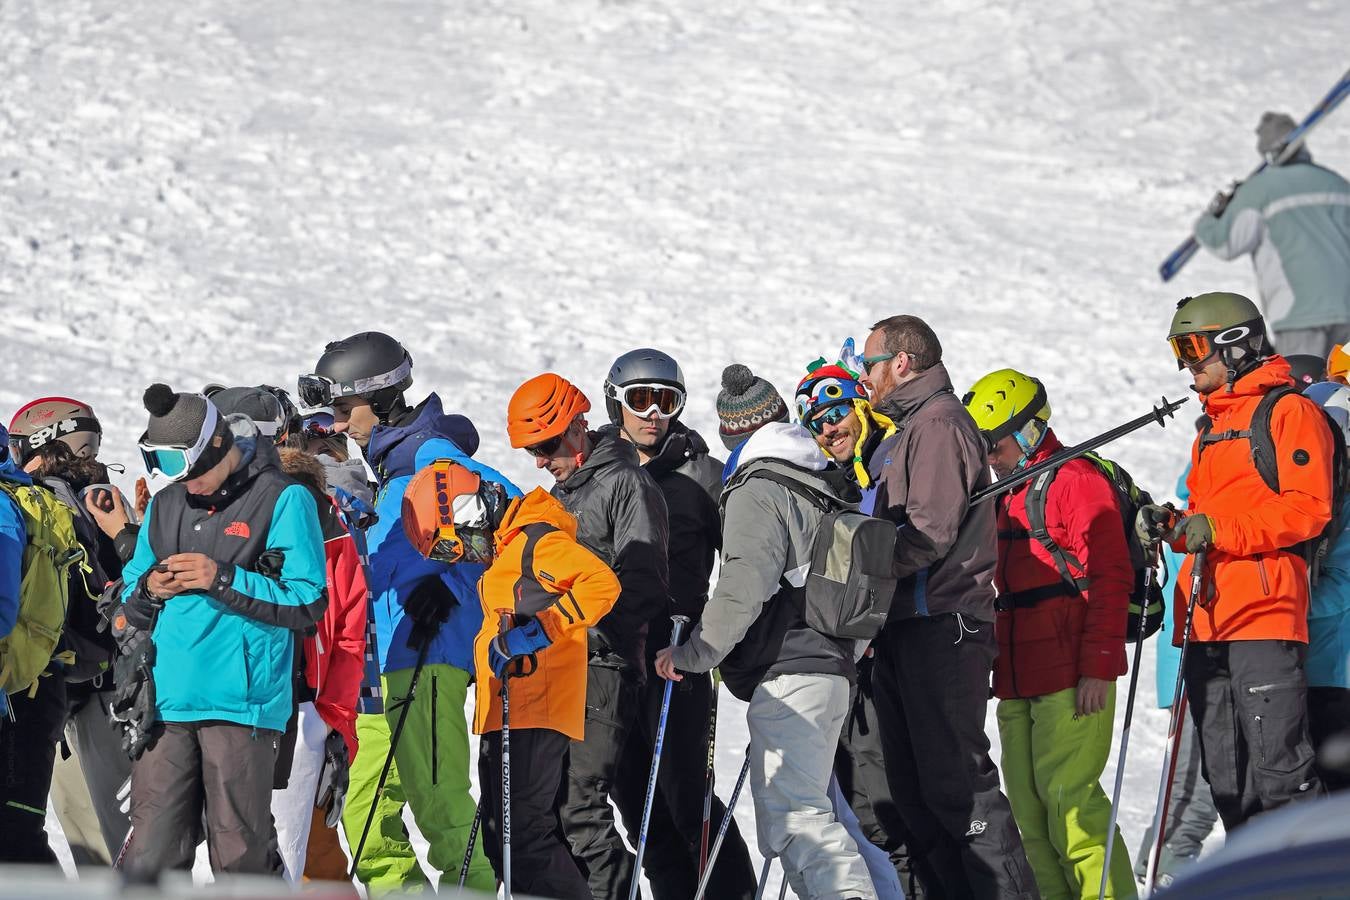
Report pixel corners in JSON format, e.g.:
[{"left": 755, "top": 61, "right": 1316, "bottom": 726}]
[{"left": 298, "top": 331, "right": 413, "bottom": 420}]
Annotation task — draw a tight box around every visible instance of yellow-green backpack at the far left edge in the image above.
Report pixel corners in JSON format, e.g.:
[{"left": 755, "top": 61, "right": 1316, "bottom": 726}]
[{"left": 0, "top": 480, "right": 85, "bottom": 696}]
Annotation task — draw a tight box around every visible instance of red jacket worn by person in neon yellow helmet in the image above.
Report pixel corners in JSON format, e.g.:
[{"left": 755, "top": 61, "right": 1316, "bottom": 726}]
[{"left": 994, "top": 430, "right": 1134, "bottom": 699}]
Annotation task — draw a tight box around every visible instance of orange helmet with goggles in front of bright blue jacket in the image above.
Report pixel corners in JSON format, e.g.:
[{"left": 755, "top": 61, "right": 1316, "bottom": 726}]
[{"left": 402, "top": 459, "right": 510, "bottom": 564}]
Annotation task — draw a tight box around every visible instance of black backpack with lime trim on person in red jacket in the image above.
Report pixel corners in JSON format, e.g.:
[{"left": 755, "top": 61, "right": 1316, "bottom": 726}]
[{"left": 1026, "top": 453, "right": 1164, "bottom": 640}]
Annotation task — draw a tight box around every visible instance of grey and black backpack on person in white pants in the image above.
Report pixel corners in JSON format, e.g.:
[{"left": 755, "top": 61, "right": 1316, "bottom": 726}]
[{"left": 749, "top": 470, "right": 899, "bottom": 641}]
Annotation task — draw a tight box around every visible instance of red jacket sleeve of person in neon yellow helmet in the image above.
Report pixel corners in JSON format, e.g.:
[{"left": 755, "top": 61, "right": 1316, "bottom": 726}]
[{"left": 1046, "top": 463, "right": 1134, "bottom": 680}]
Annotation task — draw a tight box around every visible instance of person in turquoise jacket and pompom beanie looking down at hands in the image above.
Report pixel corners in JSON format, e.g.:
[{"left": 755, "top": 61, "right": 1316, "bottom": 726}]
[{"left": 123, "top": 385, "right": 327, "bottom": 876}]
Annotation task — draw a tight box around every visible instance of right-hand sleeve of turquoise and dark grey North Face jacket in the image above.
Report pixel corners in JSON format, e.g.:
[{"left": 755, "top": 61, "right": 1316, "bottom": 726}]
[{"left": 206, "top": 484, "right": 328, "bottom": 631}]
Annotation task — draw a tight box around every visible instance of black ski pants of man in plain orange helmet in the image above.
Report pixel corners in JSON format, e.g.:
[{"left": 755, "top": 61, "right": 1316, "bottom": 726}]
[{"left": 559, "top": 656, "right": 641, "bottom": 900}]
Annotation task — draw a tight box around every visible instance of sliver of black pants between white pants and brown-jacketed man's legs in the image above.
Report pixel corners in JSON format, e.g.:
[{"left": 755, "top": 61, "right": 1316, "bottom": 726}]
[{"left": 834, "top": 657, "right": 925, "bottom": 900}]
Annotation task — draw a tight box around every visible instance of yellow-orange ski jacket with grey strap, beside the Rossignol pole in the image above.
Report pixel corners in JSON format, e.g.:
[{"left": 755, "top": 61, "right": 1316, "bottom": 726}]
[{"left": 474, "top": 487, "right": 620, "bottom": 741}]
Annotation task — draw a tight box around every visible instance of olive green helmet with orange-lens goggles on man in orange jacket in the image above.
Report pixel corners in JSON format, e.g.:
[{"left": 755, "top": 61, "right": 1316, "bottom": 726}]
[{"left": 1168, "top": 290, "right": 1273, "bottom": 381}]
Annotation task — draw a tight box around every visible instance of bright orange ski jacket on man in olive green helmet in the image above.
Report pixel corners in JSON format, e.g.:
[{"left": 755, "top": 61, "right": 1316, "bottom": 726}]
[{"left": 1173, "top": 356, "right": 1332, "bottom": 646}]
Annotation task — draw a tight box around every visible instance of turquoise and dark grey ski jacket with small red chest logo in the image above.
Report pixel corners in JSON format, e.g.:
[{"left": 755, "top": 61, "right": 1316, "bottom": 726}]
[{"left": 122, "top": 416, "right": 328, "bottom": 731}]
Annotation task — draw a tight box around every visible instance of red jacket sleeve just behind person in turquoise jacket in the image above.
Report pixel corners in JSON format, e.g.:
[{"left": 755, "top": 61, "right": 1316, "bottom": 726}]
[{"left": 315, "top": 534, "right": 370, "bottom": 760}]
